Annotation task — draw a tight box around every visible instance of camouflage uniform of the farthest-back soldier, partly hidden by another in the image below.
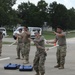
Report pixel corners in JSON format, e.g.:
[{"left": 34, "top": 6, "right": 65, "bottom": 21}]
[{"left": 17, "top": 36, "right": 24, "bottom": 58}]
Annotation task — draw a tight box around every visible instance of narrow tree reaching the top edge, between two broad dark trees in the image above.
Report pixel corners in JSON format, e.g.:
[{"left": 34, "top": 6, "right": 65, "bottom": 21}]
[{"left": 37, "top": 0, "right": 48, "bottom": 26}]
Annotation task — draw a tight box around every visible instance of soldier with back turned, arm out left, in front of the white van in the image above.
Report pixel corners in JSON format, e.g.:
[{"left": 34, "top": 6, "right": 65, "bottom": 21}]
[{"left": 19, "top": 26, "right": 30, "bottom": 64}]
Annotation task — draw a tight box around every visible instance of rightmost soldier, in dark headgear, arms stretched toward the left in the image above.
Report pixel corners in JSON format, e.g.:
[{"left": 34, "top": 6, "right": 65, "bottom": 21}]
[{"left": 49, "top": 27, "right": 67, "bottom": 69}]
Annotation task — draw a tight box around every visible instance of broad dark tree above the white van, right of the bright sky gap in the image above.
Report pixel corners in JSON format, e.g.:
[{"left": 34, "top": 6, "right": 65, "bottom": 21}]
[{"left": 18, "top": 2, "right": 37, "bottom": 26}]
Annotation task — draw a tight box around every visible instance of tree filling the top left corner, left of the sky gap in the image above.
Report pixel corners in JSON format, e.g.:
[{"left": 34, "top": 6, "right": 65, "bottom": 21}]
[{"left": 0, "top": 0, "right": 16, "bottom": 26}]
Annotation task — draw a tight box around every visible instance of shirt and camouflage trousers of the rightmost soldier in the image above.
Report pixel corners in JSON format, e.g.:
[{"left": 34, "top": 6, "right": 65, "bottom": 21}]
[{"left": 56, "top": 32, "right": 67, "bottom": 66}]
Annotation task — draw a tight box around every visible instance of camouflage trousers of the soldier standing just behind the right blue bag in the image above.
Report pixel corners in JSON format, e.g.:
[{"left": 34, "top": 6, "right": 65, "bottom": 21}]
[{"left": 22, "top": 42, "right": 30, "bottom": 61}]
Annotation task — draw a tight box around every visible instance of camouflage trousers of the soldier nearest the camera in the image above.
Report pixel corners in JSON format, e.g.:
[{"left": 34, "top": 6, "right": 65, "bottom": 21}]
[{"left": 33, "top": 51, "right": 46, "bottom": 74}]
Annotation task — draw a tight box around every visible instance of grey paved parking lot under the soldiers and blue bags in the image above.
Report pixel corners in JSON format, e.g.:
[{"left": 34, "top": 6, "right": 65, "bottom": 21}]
[{"left": 0, "top": 38, "right": 75, "bottom": 75}]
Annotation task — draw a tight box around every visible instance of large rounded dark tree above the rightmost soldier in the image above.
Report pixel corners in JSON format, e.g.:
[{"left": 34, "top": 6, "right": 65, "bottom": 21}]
[{"left": 49, "top": 2, "right": 69, "bottom": 29}]
